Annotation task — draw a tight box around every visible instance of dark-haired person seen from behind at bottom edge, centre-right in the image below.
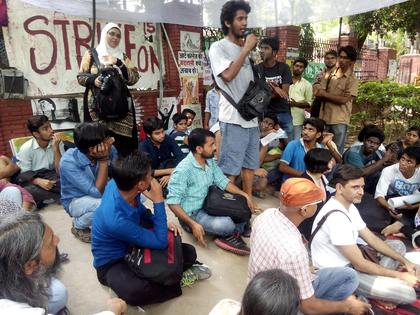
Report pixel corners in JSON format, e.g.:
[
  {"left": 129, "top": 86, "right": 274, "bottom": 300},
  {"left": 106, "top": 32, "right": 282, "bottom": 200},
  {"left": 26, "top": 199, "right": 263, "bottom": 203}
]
[{"left": 209, "top": 269, "right": 300, "bottom": 315}]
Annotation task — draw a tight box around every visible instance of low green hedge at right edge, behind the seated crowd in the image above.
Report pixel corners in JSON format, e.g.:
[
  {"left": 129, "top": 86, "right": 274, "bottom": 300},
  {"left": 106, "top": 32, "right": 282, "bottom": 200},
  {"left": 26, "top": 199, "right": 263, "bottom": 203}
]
[{"left": 351, "top": 81, "right": 420, "bottom": 138}]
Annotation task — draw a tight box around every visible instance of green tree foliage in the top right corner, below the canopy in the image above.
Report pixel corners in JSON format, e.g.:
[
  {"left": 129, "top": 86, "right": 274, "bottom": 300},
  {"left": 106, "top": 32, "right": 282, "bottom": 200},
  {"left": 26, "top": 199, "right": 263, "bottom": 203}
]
[{"left": 349, "top": 0, "right": 420, "bottom": 48}]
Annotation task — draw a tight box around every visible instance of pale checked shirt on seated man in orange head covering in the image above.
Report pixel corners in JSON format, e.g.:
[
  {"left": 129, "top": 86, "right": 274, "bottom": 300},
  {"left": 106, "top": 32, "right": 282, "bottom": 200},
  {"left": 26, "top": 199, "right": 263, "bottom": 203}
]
[{"left": 248, "top": 208, "right": 314, "bottom": 300}]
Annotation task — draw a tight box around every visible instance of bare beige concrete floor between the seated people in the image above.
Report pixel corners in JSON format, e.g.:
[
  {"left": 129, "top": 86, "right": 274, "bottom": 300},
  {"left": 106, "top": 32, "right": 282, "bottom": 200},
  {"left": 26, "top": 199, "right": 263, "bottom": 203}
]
[{"left": 41, "top": 196, "right": 278, "bottom": 315}]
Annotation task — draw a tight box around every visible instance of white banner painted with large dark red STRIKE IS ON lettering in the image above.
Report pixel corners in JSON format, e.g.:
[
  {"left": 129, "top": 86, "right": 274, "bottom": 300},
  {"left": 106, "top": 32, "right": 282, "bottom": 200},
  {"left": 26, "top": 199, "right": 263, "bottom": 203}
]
[{"left": 3, "top": 0, "right": 164, "bottom": 96}]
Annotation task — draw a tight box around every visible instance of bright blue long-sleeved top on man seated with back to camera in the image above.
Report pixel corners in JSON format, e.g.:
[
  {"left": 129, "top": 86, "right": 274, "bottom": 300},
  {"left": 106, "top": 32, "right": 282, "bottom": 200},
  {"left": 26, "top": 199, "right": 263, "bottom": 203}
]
[{"left": 92, "top": 180, "right": 168, "bottom": 268}]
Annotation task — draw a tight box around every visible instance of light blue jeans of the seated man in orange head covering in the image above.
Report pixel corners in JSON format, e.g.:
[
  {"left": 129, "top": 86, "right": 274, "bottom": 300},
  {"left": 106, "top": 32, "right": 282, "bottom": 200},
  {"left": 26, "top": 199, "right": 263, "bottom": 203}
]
[{"left": 312, "top": 267, "right": 359, "bottom": 301}]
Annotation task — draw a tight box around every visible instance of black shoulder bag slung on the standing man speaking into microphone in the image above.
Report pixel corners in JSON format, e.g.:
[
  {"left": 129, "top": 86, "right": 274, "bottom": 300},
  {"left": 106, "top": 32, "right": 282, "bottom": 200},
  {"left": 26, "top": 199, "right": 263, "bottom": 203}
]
[{"left": 220, "top": 59, "right": 272, "bottom": 121}]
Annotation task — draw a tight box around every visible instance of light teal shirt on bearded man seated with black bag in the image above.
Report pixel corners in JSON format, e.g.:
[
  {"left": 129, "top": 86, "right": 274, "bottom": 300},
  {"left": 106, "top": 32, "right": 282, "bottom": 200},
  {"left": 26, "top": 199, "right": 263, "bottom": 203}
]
[{"left": 166, "top": 152, "right": 229, "bottom": 216}]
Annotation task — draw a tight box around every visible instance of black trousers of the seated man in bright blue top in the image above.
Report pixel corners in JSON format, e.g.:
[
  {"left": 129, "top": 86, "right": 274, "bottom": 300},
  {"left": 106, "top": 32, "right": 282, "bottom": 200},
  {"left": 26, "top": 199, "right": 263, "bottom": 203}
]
[{"left": 96, "top": 243, "right": 197, "bottom": 306}]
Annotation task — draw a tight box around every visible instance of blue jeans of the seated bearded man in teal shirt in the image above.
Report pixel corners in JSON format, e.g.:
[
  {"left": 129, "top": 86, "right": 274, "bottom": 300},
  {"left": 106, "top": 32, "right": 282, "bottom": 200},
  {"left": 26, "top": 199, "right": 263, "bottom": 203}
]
[{"left": 184, "top": 210, "right": 245, "bottom": 237}]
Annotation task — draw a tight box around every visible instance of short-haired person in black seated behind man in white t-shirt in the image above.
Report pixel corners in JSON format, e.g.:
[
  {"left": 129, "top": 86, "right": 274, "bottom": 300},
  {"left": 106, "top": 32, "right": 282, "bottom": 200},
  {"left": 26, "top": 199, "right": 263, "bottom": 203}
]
[{"left": 298, "top": 148, "right": 335, "bottom": 240}]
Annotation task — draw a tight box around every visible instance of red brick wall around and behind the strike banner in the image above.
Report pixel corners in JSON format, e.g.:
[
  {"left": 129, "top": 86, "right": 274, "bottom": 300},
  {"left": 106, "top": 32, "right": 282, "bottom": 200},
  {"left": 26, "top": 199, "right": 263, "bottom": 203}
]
[{"left": 0, "top": 24, "right": 203, "bottom": 156}]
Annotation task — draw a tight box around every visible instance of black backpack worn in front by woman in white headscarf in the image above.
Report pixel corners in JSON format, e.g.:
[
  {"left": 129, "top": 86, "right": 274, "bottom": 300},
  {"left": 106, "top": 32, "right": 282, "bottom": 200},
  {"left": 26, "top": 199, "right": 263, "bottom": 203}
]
[{"left": 92, "top": 48, "right": 130, "bottom": 121}]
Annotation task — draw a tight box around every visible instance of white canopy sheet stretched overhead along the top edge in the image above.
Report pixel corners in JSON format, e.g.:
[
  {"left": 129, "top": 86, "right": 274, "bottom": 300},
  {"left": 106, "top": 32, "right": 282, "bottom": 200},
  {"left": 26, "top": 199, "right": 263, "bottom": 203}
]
[{"left": 18, "top": 0, "right": 407, "bottom": 27}]
